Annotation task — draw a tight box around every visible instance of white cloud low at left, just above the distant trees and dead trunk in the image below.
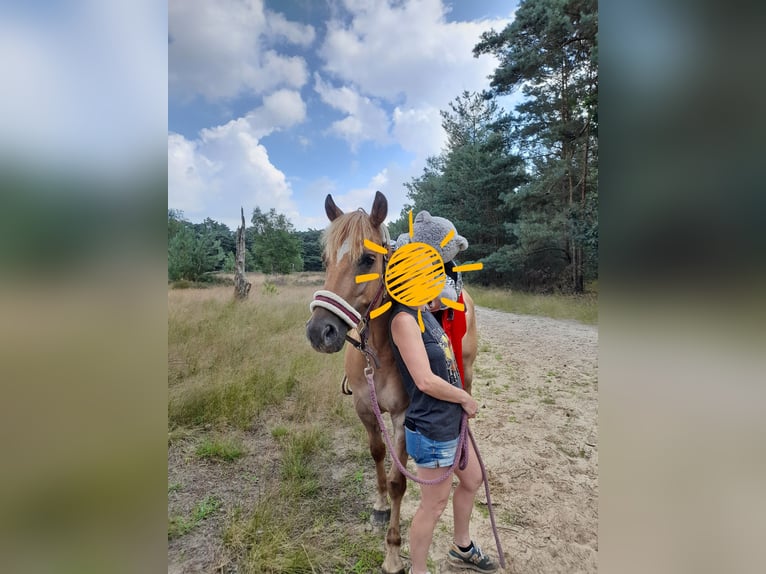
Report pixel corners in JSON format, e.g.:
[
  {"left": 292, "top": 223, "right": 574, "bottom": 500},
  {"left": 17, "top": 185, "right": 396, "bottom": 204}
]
[{"left": 168, "top": 90, "right": 306, "bottom": 228}]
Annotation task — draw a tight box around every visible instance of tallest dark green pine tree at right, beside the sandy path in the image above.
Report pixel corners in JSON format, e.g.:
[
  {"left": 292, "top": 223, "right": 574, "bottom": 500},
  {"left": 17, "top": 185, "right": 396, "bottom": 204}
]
[{"left": 474, "top": 0, "right": 598, "bottom": 292}]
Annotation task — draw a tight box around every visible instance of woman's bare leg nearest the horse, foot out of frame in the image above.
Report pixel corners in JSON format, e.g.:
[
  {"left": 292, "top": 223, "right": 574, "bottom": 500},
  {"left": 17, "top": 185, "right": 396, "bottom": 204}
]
[{"left": 410, "top": 466, "right": 452, "bottom": 574}]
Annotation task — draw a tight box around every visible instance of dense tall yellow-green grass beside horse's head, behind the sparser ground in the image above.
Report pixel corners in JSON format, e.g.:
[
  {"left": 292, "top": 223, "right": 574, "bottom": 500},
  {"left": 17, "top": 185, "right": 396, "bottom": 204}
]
[{"left": 168, "top": 279, "right": 348, "bottom": 431}]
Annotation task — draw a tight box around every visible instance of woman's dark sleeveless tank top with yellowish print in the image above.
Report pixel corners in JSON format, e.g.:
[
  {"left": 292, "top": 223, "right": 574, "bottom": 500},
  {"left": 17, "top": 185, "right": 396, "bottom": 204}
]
[{"left": 389, "top": 303, "right": 463, "bottom": 441}]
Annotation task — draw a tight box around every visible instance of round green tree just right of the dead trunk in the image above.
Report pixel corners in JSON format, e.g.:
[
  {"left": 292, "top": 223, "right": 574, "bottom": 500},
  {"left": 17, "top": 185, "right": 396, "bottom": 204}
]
[{"left": 251, "top": 207, "right": 303, "bottom": 273}]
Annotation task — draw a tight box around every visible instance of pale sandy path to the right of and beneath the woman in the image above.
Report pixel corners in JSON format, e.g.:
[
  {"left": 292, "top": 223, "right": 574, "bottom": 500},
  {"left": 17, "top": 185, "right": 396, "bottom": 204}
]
[{"left": 402, "top": 308, "right": 598, "bottom": 574}]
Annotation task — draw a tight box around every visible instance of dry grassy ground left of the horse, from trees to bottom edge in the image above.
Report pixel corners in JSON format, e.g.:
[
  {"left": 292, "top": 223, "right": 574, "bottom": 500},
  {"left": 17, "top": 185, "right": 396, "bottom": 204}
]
[{"left": 168, "top": 273, "right": 390, "bottom": 573}]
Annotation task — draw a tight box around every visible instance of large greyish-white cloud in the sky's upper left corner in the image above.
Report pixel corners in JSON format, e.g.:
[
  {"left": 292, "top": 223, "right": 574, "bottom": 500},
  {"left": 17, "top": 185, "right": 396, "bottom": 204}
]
[{"left": 168, "top": 0, "right": 315, "bottom": 101}]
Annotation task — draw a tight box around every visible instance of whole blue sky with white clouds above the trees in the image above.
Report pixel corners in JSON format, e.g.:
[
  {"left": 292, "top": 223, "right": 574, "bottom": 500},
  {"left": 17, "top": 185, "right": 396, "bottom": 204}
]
[{"left": 168, "top": 0, "right": 518, "bottom": 229}]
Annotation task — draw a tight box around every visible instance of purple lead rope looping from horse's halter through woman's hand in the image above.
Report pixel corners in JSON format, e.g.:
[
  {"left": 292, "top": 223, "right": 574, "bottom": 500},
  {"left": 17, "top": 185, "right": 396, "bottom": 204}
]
[{"left": 364, "top": 366, "right": 505, "bottom": 568}]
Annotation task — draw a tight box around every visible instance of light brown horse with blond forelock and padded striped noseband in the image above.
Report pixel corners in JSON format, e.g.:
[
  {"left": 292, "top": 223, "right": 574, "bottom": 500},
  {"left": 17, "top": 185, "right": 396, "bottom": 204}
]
[{"left": 306, "top": 191, "right": 478, "bottom": 574}]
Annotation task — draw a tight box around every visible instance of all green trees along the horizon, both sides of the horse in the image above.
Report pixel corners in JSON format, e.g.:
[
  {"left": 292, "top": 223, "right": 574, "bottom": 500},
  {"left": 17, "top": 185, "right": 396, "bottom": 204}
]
[{"left": 168, "top": 0, "right": 598, "bottom": 292}]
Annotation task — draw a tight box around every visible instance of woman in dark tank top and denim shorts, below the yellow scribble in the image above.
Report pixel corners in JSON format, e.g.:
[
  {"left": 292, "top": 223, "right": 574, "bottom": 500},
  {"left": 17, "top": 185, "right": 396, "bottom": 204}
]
[{"left": 391, "top": 292, "right": 498, "bottom": 574}]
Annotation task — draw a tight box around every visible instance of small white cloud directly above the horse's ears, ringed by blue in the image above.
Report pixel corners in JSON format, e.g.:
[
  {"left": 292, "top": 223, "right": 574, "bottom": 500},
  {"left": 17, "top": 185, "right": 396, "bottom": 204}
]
[{"left": 314, "top": 74, "right": 390, "bottom": 150}]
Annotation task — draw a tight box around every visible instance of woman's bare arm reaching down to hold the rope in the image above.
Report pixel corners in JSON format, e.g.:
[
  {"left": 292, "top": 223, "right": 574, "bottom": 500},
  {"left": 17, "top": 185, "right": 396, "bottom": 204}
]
[{"left": 391, "top": 313, "right": 478, "bottom": 417}]
